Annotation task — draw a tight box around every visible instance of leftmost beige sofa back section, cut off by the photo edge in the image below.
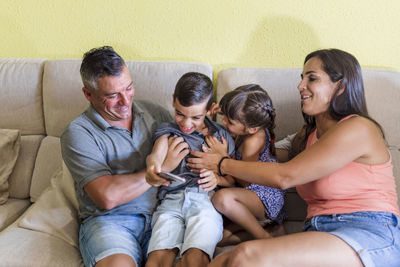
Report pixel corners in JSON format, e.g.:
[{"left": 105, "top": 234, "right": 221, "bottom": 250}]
[{"left": 0, "top": 58, "right": 45, "bottom": 199}]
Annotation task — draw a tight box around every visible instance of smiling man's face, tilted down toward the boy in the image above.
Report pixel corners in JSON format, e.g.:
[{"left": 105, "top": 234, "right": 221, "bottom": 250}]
[{"left": 83, "top": 66, "right": 135, "bottom": 125}]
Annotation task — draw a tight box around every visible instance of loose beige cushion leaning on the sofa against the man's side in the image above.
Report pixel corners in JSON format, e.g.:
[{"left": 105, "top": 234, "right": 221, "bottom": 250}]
[{"left": 19, "top": 164, "right": 79, "bottom": 248}]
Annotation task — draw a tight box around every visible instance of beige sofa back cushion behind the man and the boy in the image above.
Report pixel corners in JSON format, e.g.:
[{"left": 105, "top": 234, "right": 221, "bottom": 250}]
[{"left": 43, "top": 59, "right": 212, "bottom": 137}]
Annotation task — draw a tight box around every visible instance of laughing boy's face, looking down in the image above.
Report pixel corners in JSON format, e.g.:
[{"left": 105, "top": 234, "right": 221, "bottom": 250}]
[{"left": 172, "top": 99, "right": 207, "bottom": 134}]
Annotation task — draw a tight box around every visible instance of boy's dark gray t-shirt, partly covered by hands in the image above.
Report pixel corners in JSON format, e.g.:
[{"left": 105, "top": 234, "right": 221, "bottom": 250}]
[{"left": 153, "top": 117, "right": 235, "bottom": 199}]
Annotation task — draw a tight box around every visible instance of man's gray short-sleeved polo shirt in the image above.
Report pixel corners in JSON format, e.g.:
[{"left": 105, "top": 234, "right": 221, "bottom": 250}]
[{"left": 61, "top": 101, "right": 172, "bottom": 219}]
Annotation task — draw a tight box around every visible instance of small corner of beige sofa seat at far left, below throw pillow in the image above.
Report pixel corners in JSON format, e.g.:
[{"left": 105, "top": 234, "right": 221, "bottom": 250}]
[{"left": 0, "top": 198, "right": 31, "bottom": 231}]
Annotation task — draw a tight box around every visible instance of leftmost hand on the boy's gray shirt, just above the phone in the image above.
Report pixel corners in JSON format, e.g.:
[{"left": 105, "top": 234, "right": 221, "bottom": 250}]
[{"left": 160, "top": 137, "right": 189, "bottom": 172}]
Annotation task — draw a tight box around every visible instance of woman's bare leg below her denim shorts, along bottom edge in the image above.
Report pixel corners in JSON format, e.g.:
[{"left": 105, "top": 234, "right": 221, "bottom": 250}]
[{"left": 209, "top": 231, "right": 363, "bottom": 267}]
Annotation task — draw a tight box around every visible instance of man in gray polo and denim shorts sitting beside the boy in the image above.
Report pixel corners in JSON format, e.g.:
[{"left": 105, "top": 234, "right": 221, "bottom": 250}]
[{"left": 61, "top": 46, "right": 187, "bottom": 266}]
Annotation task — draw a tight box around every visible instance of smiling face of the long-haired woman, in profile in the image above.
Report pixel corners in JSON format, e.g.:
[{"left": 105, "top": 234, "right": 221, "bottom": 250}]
[{"left": 297, "top": 57, "right": 340, "bottom": 116}]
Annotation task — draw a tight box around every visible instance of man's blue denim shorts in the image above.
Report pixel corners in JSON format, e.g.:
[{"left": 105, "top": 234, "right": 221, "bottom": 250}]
[{"left": 79, "top": 214, "right": 151, "bottom": 266}]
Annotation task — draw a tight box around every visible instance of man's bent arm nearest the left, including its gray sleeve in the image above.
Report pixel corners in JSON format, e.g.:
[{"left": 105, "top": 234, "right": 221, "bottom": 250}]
[{"left": 60, "top": 125, "right": 156, "bottom": 210}]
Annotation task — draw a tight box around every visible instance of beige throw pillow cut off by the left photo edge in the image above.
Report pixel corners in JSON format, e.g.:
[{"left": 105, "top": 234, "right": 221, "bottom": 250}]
[{"left": 0, "top": 129, "right": 20, "bottom": 205}]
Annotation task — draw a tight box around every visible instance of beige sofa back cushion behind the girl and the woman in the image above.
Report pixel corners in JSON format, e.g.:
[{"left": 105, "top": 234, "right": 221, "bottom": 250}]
[{"left": 217, "top": 68, "right": 400, "bottom": 209}]
